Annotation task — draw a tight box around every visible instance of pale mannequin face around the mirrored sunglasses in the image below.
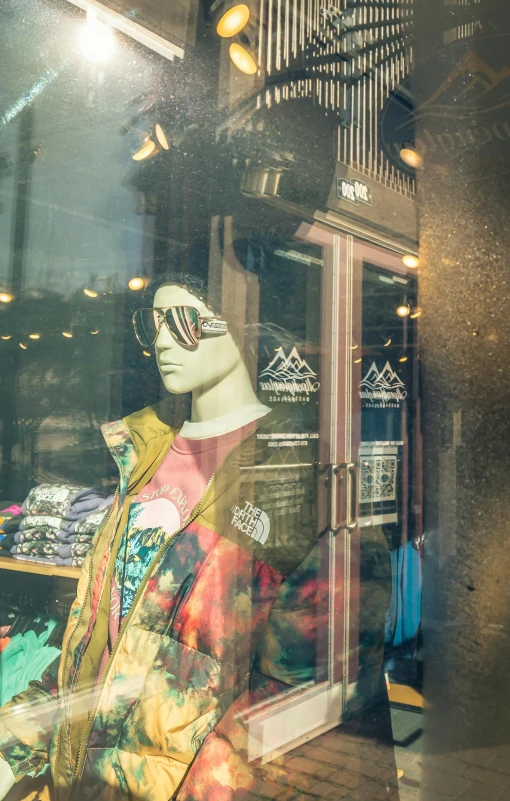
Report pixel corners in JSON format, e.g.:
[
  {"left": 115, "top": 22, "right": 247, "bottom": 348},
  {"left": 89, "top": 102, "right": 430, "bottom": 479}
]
[{"left": 153, "top": 285, "right": 244, "bottom": 395}]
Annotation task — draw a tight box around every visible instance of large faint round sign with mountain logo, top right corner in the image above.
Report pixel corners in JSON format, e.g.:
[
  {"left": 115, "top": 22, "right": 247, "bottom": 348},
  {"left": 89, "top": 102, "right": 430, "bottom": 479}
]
[{"left": 380, "top": 40, "right": 510, "bottom": 184}]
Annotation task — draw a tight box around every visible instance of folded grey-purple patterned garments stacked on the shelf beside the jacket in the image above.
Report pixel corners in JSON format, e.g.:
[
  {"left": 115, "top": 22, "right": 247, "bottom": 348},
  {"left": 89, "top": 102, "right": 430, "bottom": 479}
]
[{"left": 11, "top": 484, "right": 113, "bottom": 567}]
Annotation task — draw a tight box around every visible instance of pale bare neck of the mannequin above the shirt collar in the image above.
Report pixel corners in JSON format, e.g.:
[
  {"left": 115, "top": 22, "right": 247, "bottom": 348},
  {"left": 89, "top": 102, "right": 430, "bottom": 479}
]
[{"left": 191, "top": 361, "right": 259, "bottom": 423}]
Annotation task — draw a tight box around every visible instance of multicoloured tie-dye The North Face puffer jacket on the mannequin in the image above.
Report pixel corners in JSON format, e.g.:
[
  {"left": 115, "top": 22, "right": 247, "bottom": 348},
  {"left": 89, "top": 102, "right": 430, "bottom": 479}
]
[{"left": 0, "top": 407, "right": 391, "bottom": 801}]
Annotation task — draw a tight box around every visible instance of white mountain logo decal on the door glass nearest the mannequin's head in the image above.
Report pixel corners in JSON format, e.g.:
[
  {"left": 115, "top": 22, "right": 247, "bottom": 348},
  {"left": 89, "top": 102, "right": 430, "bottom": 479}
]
[{"left": 259, "top": 346, "right": 320, "bottom": 400}]
